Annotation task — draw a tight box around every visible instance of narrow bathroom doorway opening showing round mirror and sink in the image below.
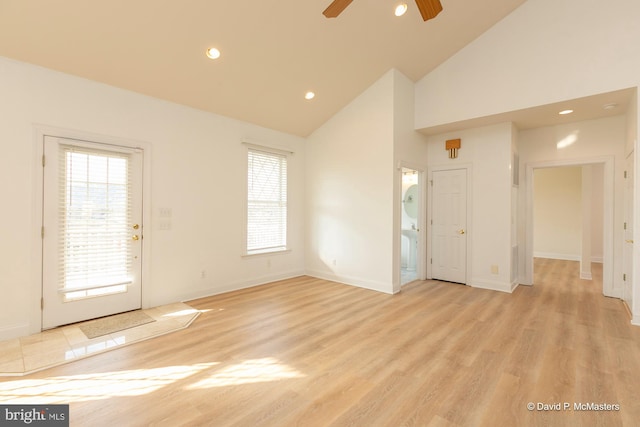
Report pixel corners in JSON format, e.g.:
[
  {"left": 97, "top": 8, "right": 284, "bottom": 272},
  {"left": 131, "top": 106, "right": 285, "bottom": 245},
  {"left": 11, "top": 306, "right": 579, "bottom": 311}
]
[{"left": 400, "top": 167, "right": 423, "bottom": 285}]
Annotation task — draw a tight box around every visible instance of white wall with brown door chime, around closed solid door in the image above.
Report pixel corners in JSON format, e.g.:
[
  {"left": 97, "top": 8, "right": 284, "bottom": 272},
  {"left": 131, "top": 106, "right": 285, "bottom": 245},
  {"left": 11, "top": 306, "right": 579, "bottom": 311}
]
[{"left": 428, "top": 123, "right": 513, "bottom": 292}]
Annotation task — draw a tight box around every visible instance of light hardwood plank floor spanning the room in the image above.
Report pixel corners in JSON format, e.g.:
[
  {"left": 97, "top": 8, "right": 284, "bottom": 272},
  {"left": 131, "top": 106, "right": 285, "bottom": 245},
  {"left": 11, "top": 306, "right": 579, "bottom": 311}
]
[{"left": 0, "top": 259, "right": 640, "bottom": 427}]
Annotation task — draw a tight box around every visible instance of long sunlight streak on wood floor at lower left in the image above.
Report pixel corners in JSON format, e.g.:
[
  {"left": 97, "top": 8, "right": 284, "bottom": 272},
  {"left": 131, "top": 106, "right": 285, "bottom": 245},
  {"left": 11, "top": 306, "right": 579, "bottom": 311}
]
[{"left": 0, "top": 363, "right": 217, "bottom": 404}]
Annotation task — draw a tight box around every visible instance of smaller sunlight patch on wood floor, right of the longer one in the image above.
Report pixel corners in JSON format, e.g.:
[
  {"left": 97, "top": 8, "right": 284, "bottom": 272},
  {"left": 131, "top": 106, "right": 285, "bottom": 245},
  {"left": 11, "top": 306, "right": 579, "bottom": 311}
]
[{"left": 187, "top": 357, "right": 305, "bottom": 390}]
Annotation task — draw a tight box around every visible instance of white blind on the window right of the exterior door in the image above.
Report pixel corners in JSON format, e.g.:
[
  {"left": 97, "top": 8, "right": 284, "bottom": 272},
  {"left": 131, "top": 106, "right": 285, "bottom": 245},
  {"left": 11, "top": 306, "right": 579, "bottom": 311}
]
[{"left": 246, "top": 148, "right": 287, "bottom": 254}]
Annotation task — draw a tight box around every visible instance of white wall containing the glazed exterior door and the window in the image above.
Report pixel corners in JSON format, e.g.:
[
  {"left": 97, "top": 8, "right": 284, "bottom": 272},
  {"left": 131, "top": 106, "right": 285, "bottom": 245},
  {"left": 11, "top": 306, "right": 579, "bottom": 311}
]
[{"left": 0, "top": 58, "right": 306, "bottom": 339}]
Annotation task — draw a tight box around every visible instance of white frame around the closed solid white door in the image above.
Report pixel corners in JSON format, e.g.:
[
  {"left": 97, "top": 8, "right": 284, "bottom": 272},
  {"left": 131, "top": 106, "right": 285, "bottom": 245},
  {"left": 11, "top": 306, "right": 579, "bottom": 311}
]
[{"left": 424, "top": 163, "right": 473, "bottom": 286}]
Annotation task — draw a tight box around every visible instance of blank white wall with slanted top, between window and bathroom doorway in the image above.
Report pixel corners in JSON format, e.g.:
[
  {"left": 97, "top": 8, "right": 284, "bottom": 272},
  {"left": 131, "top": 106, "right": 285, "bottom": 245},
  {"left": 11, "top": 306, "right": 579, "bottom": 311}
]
[{"left": 305, "top": 70, "right": 395, "bottom": 293}]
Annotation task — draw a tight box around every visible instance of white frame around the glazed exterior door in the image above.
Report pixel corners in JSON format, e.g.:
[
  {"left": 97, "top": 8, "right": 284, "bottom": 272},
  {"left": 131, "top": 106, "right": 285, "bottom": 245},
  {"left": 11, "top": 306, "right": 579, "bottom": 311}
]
[{"left": 28, "top": 125, "right": 152, "bottom": 334}]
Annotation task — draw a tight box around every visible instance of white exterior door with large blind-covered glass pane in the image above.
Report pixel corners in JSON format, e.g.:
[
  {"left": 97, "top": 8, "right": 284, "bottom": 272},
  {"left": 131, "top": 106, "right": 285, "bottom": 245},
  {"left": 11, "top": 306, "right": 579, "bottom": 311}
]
[{"left": 42, "top": 136, "right": 143, "bottom": 329}]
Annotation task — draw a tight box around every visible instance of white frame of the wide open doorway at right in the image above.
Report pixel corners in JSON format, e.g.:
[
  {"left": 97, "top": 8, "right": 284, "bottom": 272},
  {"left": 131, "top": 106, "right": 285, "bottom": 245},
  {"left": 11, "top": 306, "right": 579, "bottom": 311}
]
[{"left": 521, "top": 156, "right": 621, "bottom": 298}]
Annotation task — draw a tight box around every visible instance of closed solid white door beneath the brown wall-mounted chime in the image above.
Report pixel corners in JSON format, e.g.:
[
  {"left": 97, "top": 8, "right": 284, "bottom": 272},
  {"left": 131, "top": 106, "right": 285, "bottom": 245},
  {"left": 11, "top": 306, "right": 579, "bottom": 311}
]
[{"left": 431, "top": 169, "right": 467, "bottom": 284}]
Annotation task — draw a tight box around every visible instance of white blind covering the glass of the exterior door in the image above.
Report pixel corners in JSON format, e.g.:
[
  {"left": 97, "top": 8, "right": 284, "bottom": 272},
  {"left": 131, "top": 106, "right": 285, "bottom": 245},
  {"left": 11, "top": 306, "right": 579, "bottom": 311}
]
[{"left": 58, "top": 146, "right": 132, "bottom": 300}]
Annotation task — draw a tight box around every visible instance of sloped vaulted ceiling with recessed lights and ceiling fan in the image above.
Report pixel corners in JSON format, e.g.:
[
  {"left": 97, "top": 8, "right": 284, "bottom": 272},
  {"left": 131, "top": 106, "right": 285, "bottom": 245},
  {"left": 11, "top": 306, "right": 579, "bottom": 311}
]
[{"left": 0, "top": 0, "right": 525, "bottom": 136}]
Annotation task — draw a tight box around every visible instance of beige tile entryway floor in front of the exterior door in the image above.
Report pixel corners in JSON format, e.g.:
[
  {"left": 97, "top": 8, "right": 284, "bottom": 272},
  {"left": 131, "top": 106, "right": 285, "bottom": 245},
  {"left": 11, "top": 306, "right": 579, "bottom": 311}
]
[{"left": 0, "top": 303, "right": 200, "bottom": 376}]
